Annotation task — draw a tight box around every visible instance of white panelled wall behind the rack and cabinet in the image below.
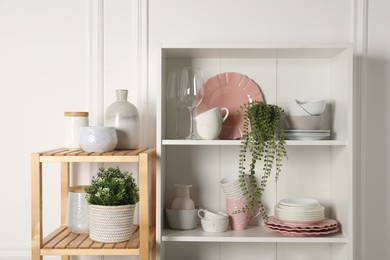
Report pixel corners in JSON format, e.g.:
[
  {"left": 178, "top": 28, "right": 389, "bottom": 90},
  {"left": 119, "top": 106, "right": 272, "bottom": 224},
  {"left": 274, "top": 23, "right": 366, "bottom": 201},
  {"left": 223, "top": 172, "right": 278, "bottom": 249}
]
[{"left": 0, "top": 0, "right": 390, "bottom": 259}]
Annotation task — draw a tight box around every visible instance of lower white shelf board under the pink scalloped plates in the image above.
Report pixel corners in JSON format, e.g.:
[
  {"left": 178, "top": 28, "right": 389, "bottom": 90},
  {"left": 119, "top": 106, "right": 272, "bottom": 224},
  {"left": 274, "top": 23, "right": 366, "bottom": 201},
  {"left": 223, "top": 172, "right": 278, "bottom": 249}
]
[{"left": 162, "top": 226, "right": 348, "bottom": 243}]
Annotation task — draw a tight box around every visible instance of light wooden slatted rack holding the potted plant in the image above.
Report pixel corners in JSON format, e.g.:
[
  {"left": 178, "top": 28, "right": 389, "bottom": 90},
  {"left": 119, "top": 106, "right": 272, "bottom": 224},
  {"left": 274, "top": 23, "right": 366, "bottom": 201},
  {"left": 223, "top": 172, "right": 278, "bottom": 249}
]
[{"left": 31, "top": 148, "right": 156, "bottom": 260}]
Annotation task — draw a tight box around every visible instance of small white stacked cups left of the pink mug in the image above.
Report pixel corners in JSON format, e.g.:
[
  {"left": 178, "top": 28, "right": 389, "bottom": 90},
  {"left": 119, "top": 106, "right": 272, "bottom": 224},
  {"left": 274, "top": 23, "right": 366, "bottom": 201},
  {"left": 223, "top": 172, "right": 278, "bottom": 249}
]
[{"left": 198, "top": 209, "right": 229, "bottom": 233}]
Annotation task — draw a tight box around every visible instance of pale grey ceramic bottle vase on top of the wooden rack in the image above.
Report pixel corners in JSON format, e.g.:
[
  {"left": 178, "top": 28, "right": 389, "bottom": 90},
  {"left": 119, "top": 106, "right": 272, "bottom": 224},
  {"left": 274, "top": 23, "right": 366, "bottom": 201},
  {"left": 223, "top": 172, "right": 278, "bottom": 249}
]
[{"left": 104, "top": 89, "right": 140, "bottom": 149}]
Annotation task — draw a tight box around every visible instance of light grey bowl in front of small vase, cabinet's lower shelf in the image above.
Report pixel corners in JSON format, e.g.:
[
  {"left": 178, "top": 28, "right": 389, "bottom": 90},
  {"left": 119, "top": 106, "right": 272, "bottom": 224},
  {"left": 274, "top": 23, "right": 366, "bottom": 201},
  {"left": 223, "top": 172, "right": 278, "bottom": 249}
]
[{"left": 165, "top": 208, "right": 199, "bottom": 230}]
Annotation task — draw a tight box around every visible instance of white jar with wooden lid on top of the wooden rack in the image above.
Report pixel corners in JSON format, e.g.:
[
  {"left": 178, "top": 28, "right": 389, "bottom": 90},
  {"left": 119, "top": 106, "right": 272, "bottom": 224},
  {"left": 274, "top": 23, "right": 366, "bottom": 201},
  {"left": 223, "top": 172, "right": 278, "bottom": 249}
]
[{"left": 64, "top": 112, "right": 89, "bottom": 150}]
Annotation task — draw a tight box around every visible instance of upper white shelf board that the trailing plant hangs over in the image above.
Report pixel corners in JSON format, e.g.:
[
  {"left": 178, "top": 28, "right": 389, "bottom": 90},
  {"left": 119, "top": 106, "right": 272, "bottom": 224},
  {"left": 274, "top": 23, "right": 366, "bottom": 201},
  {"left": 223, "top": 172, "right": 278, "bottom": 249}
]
[{"left": 162, "top": 139, "right": 348, "bottom": 146}]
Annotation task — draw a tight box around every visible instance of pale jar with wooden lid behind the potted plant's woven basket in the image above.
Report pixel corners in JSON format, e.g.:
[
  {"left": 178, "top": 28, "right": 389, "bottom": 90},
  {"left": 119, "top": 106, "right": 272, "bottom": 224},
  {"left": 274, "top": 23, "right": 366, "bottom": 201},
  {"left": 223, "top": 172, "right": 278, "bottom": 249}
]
[{"left": 66, "top": 186, "right": 89, "bottom": 234}]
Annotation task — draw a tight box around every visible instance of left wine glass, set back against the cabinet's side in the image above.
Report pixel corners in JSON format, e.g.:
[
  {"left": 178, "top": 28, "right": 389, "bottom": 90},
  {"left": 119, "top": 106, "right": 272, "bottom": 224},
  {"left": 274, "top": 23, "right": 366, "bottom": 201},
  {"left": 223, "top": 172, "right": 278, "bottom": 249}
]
[{"left": 166, "top": 71, "right": 184, "bottom": 139}]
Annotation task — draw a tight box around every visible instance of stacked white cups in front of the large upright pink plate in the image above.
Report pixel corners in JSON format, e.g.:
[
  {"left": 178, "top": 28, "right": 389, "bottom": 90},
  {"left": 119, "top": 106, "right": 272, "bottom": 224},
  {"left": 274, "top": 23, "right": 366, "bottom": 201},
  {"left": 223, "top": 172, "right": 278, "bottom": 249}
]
[{"left": 195, "top": 107, "right": 229, "bottom": 140}]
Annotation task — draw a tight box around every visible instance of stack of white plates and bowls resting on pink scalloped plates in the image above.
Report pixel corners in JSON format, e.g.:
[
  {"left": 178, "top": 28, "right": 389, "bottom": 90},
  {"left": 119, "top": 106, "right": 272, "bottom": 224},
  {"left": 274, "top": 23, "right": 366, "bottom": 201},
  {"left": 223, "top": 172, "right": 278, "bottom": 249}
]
[{"left": 275, "top": 198, "right": 325, "bottom": 223}]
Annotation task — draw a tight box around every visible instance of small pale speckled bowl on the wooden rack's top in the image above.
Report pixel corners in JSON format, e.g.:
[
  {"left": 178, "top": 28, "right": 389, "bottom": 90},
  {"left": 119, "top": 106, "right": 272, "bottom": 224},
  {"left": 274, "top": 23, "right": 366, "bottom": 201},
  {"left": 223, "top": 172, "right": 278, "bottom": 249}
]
[{"left": 80, "top": 126, "right": 118, "bottom": 152}]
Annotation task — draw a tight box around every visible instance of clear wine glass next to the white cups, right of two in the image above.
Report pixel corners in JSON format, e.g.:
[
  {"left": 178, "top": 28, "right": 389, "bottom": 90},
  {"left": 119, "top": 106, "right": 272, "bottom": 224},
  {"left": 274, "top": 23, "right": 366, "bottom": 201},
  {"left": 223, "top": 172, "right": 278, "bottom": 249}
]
[{"left": 180, "top": 66, "right": 203, "bottom": 139}]
